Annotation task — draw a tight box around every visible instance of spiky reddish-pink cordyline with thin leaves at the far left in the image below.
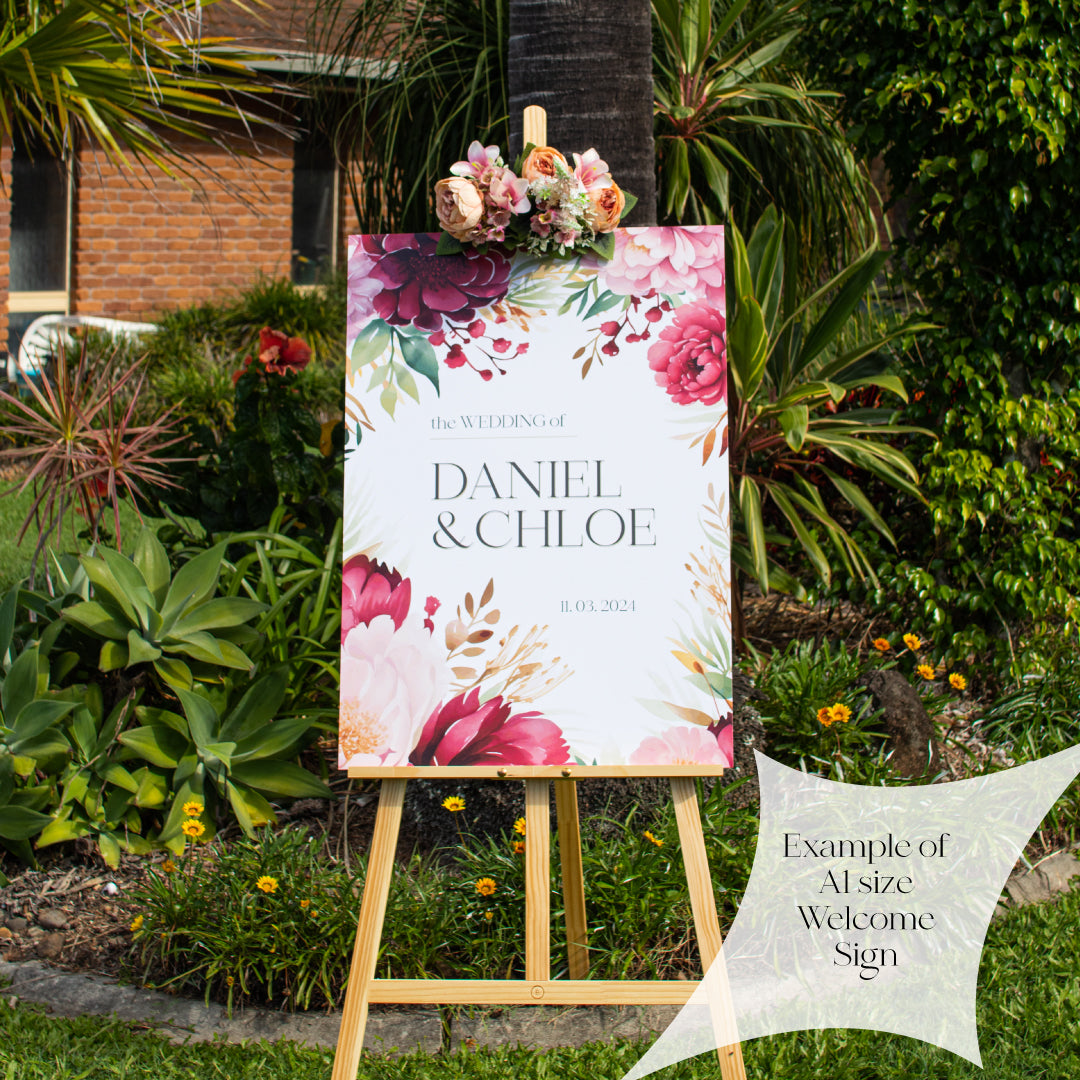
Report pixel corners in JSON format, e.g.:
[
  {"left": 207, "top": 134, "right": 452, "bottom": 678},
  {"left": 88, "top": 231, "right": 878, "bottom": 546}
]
[{"left": 0, "top": 340, "right": 183, "bottom": 580}]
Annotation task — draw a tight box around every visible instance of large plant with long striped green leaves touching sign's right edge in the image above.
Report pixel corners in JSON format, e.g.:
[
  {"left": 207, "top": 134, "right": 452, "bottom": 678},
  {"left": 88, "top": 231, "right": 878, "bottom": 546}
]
[{"left": 721, "top": 208, "right": 932, "bottom": 626}]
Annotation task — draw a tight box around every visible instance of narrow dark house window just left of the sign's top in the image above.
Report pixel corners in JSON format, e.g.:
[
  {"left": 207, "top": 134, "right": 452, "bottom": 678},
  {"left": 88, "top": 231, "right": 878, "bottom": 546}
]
[{"left": 293, "top": 136, "right": 338, "bottom": 285}]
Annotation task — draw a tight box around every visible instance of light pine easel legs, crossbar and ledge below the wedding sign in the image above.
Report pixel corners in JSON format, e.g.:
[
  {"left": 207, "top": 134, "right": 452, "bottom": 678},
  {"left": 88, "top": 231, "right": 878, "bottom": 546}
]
[{"left": 332, "top": 766, "right": 746, "bottom": 1080}]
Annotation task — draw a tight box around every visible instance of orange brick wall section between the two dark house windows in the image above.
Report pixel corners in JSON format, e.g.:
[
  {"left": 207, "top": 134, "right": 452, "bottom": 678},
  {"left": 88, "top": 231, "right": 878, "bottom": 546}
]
[{"left": 72, "top": 127, "right": 293, "bottom": 320}]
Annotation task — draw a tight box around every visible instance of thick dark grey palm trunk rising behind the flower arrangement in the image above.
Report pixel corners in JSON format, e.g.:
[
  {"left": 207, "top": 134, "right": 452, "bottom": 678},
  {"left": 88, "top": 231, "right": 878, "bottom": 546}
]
[{"left": 509, "top": 0, "right": 657, "bottom": 225}]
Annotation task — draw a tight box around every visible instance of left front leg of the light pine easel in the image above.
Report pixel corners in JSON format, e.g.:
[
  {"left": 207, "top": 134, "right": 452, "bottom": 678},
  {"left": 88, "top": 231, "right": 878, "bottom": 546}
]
[{"left": 330, "top": 780, "right": 405, "bottom": 1080}]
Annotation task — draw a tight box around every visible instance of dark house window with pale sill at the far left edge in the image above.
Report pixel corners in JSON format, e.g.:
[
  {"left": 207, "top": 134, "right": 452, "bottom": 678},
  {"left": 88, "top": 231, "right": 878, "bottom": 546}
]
[{"left": 8, "top": 145, "right": 71, "bottom": 354}]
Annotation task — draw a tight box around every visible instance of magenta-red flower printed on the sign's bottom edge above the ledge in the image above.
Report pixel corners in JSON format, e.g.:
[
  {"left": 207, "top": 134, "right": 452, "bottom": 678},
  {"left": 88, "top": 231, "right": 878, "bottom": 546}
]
[{"left": 409, "top": 690, "right": 570, "bottom": 765}]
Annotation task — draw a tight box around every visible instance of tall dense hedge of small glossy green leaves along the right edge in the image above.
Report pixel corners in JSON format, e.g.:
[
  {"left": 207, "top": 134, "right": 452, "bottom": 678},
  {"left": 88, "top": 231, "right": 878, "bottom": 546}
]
[{"left": 806, "top": 0, "right": 1080, "bottom": 676}]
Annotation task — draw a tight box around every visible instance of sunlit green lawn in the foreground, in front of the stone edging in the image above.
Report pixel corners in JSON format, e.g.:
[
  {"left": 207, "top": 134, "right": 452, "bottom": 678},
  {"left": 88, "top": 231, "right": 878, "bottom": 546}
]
[{"left": 0, "top": 892, "right": 1080, "bottom": 1080}]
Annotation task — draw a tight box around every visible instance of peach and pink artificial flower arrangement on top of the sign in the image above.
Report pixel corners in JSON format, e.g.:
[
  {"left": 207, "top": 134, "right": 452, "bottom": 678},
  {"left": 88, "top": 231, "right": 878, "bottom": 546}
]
[{"left": 435, "top": 140, "right": 637, "bottom": 259}]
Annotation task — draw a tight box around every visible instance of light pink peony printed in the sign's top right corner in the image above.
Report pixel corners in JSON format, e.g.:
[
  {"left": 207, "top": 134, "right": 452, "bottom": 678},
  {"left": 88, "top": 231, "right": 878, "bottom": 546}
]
[{"left": 597, "top": 225, "right": 724, "bottom": 311}]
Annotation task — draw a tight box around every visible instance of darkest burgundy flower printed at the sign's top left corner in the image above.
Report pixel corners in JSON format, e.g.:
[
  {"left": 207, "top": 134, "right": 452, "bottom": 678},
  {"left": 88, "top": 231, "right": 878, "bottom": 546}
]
[{"left": 363, "top": 232, "right": 510, "bottom": 330}]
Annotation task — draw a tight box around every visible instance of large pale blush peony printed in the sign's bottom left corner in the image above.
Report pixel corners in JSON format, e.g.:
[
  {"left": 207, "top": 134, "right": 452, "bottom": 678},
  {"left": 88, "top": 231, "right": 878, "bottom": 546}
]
[{"left": 338, "top": 615, "right": 448, "bottom": 769}]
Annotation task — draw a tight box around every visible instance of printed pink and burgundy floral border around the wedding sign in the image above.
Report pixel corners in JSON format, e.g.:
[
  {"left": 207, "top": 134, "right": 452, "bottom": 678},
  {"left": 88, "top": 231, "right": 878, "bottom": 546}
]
[{"left": 339, "top": 225, "right": 732, "bottom": 767}]
